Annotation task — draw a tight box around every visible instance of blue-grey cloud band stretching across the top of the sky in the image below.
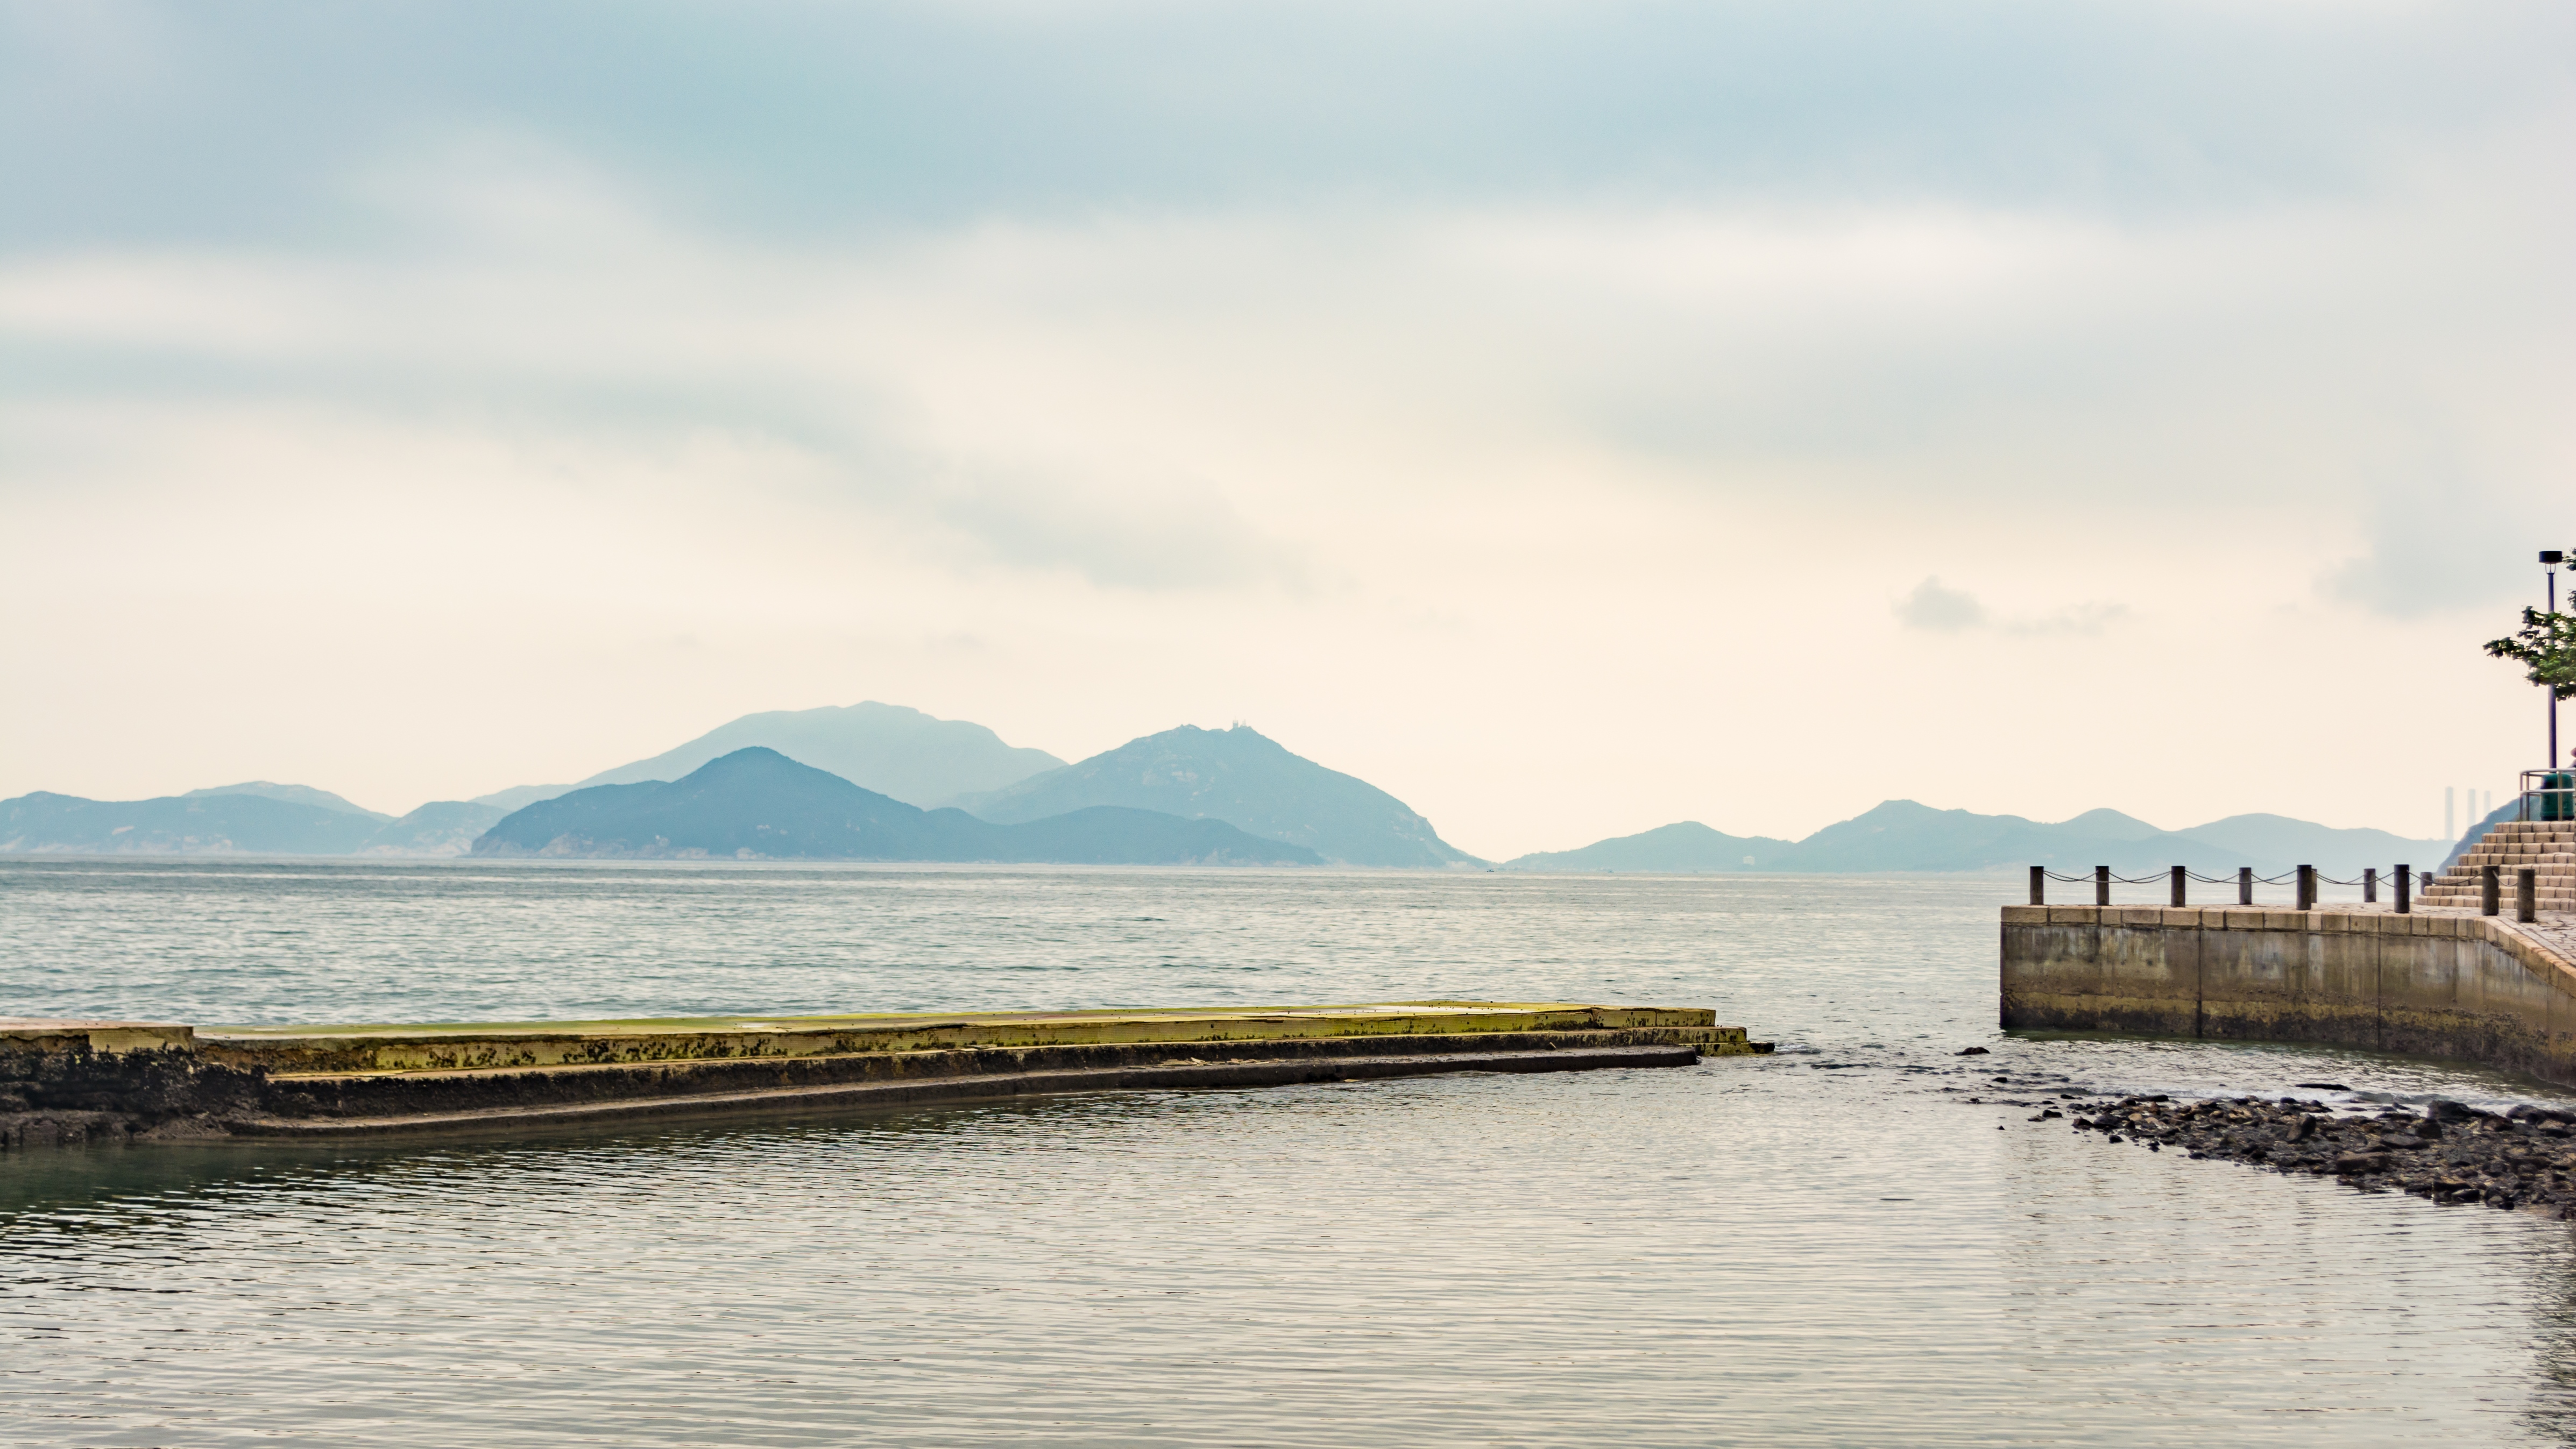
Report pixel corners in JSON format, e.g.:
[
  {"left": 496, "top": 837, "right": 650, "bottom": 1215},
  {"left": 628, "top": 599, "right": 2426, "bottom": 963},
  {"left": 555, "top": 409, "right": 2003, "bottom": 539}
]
[{"left": 0, "top": 0, "right": 2576, "bottom": 242}]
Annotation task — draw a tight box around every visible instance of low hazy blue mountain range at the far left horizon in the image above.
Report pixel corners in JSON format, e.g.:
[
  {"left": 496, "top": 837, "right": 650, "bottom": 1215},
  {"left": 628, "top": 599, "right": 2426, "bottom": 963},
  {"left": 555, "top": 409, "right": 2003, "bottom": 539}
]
[{"left": 0, "top": 790, "right": 384, "bottom": 855}]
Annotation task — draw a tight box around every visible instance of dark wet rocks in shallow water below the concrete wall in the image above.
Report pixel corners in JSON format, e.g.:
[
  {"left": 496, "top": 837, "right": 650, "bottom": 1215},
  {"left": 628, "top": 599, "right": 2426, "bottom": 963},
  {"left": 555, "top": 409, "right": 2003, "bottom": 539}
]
[{"left": 2033, "top": 1096, "right": 2576, "bottom": 1217}]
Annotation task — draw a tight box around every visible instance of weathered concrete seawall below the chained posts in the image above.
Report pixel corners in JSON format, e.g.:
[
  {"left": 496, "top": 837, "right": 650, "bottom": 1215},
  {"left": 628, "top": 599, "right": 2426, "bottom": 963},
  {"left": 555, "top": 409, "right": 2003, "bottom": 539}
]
[{"left": 2001, "top": 906, "right": 2576, "bottom": 1084}]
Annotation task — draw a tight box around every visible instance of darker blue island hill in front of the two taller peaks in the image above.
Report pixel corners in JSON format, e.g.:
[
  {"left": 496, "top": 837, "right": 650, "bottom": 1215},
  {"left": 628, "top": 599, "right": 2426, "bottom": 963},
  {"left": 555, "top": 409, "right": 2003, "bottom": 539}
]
[{"left": 474, "top": 747, "right": 1319, "bottom": 865}]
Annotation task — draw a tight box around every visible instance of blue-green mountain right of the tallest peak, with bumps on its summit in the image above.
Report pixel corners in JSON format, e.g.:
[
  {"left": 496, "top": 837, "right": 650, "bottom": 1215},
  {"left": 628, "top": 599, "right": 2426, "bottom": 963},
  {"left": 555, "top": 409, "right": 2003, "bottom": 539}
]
[{"left": 958, "top": 726, "right": 1481, "bottom": 868}]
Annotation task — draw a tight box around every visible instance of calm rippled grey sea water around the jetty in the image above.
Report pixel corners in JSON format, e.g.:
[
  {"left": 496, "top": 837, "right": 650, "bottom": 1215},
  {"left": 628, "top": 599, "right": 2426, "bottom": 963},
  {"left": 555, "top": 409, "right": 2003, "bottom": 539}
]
[{"left": 0, "top": 860, "right": 2576, "bottom": 1446}]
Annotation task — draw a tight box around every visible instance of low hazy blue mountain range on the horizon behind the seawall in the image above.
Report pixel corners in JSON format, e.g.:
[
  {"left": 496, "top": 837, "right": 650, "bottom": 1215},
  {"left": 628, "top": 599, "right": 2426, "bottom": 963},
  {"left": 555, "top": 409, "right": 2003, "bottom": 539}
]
[{"left": 1510, "top": 800, "right": 2442, "bottom": 878}]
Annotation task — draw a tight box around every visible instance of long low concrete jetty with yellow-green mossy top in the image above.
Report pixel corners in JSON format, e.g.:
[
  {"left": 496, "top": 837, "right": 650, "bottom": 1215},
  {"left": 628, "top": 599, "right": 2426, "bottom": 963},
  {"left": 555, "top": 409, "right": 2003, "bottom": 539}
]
[{"left": 0, "top": 1001, "right": 1770, "bottom": 1148}]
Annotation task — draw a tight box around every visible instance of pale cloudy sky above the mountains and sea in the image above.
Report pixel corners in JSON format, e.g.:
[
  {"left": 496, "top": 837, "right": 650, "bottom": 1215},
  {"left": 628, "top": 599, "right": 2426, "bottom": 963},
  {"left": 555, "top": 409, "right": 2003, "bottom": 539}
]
[{"left": 0, "top": 0, "right": 2576, "bottom": 857}]
